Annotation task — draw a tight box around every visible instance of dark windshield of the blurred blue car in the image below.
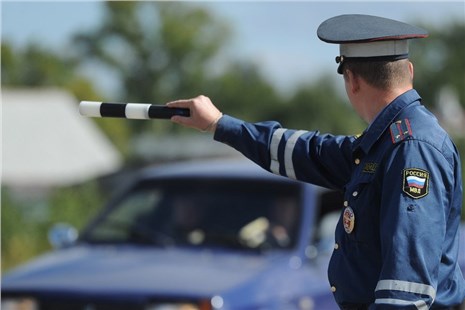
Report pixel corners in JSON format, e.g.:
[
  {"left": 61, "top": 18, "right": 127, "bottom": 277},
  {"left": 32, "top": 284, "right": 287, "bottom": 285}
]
[{"left": 83, "top": 179, "right": 301, "bottom": 250}]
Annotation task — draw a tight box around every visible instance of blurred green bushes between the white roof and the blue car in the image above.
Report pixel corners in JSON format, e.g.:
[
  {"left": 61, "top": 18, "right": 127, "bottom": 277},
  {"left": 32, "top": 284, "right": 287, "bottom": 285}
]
[{"left": 1, "top": 182, "right": 104, "bottom": 271}]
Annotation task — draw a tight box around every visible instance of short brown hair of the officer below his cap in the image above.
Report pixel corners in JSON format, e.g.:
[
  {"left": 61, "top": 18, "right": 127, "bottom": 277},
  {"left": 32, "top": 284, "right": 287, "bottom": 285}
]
[{"left": 343, "top": 59, "right": 412, "bottom": 90}]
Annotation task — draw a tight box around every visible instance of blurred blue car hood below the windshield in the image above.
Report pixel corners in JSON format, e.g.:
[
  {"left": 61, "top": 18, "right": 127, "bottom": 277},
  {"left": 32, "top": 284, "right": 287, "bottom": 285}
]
[{"left": 2, "top": 246, "right": 288, "bottom": 297}]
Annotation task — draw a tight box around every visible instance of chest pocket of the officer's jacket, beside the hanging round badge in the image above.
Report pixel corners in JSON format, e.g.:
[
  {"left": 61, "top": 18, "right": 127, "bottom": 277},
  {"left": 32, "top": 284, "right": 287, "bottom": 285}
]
[{"left": 343, "top": 172, "right": 380, "bottom": 246}]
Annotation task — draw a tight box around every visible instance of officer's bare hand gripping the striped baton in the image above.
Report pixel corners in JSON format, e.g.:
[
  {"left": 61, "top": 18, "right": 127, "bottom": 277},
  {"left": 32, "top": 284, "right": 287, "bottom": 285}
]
[{"left": 166, "top": 96, "right": 223, "bottom": 132}]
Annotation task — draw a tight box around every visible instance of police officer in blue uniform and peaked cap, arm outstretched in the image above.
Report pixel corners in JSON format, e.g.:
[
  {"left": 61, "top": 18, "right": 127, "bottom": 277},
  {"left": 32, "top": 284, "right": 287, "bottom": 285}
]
[{"left": 168, "top": 15, "right": 465, "bottom": 309}]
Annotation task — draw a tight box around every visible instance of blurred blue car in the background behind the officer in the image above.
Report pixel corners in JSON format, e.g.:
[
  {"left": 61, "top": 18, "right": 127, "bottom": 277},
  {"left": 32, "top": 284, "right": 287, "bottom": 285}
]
[{"left": 2, "top": 161, "right": 462, "bottom": 310}]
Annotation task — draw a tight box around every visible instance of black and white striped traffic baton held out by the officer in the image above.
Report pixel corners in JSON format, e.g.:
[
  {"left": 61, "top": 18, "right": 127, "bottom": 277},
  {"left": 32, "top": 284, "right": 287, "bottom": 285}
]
[{"left": 79, "top": 101, "right": 190, "bottom": 119}]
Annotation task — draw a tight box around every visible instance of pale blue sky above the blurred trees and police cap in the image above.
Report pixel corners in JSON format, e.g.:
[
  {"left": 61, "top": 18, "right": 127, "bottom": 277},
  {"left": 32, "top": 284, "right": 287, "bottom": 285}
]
[{"left": 1, "top": 0, "right": 465, "bottom": 95}]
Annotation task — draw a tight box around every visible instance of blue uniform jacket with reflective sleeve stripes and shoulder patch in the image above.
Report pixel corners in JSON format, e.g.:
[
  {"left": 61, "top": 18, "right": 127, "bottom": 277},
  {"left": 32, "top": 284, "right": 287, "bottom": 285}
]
[{"left": 214, "top": 90, "right": 465, "bottom": 309}]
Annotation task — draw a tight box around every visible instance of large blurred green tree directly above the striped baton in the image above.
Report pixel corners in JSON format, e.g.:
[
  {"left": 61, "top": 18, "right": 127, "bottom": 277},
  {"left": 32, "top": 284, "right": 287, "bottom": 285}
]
[{"left": 75, "top": 1, "right": 228, "bottom": 135}]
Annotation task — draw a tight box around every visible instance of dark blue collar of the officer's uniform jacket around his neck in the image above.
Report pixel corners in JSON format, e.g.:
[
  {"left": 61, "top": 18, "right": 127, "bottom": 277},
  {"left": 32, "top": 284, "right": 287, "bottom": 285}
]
[{"left": 356, "top": 89, "right": 421, "bottom": 154}]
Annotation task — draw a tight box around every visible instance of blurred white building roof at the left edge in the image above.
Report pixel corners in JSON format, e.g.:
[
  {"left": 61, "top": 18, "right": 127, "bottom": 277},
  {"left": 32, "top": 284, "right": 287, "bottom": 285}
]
[{"left": 1, "top": 89, "right": 122, "bottom": 187}]
